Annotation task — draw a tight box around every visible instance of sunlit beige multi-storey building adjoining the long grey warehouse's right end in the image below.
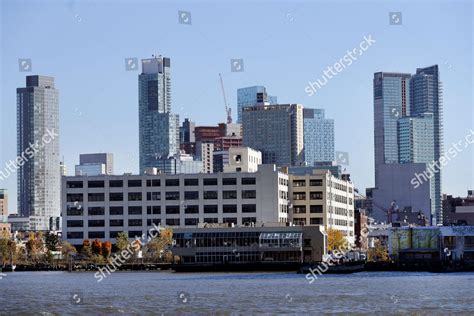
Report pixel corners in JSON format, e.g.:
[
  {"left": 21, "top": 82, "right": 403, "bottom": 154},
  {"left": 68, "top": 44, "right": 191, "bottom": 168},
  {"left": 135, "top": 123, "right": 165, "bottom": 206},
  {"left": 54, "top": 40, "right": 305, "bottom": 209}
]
[{"left": 289, "top": 169, "right": 355, "bottom": 244}]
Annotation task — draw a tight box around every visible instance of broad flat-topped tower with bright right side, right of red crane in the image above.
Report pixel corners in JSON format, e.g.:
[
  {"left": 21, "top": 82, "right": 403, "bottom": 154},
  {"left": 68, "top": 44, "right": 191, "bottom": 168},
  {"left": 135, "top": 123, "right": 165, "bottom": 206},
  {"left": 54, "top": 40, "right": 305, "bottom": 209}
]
[{"left": 242, "top": 104, "right": 303, "bottom": 166}]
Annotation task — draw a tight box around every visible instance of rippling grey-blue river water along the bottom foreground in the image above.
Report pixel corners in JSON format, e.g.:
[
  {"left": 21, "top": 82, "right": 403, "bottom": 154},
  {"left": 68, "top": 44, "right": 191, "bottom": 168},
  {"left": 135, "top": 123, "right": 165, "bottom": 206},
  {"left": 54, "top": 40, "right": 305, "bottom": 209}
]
[{"left": 0, "top": 272, "right": 474, "bottom": 315}]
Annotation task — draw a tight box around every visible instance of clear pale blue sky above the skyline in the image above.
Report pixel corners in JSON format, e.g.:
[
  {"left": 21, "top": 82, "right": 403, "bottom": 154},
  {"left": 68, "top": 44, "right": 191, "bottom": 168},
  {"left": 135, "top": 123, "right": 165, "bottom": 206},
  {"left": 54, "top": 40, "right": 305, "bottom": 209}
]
[{"left": 0, "top": 0, "right": 474, "bottom": 212}]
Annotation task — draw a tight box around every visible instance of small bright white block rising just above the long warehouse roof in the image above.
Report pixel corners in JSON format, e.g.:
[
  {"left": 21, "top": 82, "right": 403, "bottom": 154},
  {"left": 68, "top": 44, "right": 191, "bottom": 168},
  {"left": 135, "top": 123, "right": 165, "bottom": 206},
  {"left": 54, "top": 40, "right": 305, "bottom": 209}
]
[{"left": 224, "top": 147, "right": 262, "bottom": 172}]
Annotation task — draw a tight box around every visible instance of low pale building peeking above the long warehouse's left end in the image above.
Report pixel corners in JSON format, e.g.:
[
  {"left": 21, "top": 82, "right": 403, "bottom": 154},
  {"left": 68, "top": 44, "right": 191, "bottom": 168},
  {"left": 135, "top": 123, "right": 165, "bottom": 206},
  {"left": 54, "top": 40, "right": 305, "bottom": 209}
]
[{"left": 76, "top": 153, "right": 114, "bottom": 176}]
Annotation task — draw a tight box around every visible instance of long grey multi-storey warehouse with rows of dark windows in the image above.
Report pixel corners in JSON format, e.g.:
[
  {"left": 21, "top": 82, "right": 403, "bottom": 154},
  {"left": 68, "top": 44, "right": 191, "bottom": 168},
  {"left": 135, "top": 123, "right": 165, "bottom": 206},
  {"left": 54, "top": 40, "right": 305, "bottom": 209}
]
[{"left": 62, "top": 165, "right": 288, "bottom": 245}]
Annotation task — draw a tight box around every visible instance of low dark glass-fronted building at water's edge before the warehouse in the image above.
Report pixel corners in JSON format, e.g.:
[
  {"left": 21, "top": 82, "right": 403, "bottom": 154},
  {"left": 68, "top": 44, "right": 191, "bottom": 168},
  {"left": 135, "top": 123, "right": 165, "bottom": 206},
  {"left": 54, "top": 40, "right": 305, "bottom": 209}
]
[{"left": 171, "top": 224, "right": 327, "bottom": 271}]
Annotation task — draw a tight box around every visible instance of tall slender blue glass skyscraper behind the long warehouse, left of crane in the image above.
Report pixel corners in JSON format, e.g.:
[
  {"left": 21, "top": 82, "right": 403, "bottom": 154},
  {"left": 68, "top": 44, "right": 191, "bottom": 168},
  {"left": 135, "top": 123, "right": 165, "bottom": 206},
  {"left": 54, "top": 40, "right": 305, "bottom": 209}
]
[{"left": 138, "top": 56, "right": 179, "bottom": 173}]
